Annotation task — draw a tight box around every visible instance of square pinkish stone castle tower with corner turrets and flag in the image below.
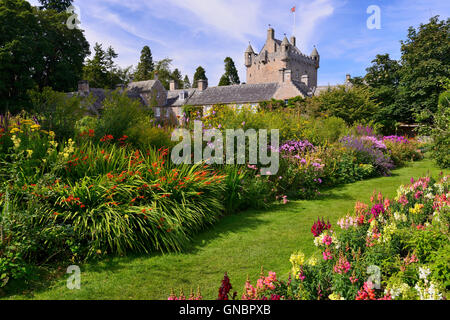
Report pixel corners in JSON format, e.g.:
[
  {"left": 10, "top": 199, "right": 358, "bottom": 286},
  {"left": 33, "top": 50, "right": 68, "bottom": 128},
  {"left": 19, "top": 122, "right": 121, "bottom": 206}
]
[{"left": 245, "top": 27, "right": 320, "bottom": 88}]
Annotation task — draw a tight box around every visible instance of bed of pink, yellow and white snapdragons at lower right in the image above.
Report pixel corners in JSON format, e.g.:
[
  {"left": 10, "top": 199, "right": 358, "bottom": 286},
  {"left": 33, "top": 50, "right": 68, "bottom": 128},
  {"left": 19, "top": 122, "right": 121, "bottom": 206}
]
[{"left": 175, "top": 176, "right": 450, "bottom": 300}]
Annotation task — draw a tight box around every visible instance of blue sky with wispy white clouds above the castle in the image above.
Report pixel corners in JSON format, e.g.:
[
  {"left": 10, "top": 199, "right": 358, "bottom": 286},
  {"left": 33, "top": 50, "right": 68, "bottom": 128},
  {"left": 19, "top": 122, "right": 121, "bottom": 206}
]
[{"left": 29, "top": 0, "right": 450, "bottom": 85}]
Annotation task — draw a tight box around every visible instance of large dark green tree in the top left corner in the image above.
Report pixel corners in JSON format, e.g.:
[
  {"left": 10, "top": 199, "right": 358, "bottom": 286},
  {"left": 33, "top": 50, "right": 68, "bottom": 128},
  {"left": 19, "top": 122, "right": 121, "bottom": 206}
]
[{"left": 0, "top": 0, "right": 89, "bottom": 112}]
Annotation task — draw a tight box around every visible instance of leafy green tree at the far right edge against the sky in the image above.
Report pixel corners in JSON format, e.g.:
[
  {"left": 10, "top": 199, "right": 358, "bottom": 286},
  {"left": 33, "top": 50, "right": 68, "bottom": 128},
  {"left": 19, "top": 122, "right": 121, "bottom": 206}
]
[{"left": 399, "top": 16, "right": 450, "bottom": 122}]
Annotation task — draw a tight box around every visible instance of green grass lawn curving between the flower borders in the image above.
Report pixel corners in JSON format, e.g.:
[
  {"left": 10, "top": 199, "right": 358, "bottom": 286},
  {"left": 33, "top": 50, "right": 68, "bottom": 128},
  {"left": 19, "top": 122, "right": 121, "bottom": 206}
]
[{"left": 4, "top": 160, "right": 448, "bottom": 300}]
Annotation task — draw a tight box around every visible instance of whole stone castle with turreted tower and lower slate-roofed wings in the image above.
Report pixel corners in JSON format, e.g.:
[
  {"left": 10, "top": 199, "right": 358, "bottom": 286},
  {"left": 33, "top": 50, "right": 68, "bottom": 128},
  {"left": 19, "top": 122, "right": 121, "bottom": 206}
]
[{"left": 77, "top": 27, "right": 350, "bottom": 121}]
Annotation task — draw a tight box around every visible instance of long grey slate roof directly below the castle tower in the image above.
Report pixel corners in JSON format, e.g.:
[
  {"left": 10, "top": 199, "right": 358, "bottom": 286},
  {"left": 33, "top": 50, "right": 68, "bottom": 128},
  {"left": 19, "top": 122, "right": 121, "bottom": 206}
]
[{"left": 186, "top": 83, "right": 279, "bottom": 105}]
